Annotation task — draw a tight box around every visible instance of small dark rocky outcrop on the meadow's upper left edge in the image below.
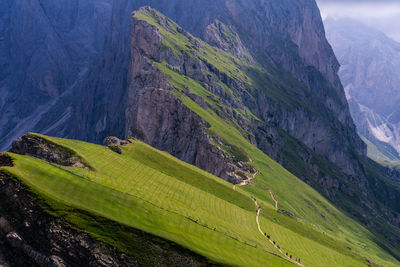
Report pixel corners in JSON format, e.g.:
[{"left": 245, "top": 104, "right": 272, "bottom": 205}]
[{"left": 10, "top": 134, "right": 90, "bottom": 168}]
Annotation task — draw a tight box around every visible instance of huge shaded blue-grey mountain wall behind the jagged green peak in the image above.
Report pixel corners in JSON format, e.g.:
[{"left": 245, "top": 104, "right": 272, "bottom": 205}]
[{"left": 0, "top": 0, "right": 363, "bottom": 165}]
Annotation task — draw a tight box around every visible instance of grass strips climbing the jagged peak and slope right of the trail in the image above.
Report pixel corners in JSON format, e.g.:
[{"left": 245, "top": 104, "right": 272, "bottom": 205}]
[{"left": 130, "top": 7, "right": 397, "bottom": 266}]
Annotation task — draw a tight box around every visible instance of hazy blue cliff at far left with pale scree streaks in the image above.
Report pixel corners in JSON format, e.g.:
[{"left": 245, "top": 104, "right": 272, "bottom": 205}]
[{"left": 0, "top": 0, "right": 112, "bottom": 149}]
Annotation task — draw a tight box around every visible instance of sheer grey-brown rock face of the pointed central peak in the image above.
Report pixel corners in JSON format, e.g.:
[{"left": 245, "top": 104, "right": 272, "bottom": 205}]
[{"left": 125, "top": 13, "right": 255, "bottom": 183}]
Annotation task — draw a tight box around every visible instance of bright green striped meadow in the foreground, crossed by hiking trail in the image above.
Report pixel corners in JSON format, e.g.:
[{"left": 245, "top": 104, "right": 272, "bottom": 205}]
[{"left": 1, "top": 134, "right": 396, "bottom": 266}]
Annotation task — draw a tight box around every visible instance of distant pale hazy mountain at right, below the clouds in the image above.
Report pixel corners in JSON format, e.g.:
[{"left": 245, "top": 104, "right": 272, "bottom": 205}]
[{"left": 325, "top": 19, "right": 400, "bottom": 161}]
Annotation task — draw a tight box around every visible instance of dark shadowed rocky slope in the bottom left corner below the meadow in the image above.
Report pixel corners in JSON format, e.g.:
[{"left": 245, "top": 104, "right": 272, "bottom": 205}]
[{"left": 0, "top": 172, "right": 220, "bottom": 267}]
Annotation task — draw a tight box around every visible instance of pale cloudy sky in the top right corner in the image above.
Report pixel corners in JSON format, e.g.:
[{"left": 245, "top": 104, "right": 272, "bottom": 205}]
[{"left": 317, "top": 0, "right": 400, "bottom": 42}]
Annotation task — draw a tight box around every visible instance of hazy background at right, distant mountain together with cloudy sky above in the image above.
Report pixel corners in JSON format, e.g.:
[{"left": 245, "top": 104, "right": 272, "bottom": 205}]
[{"left": 320, "top": 1, "right": 400, "bottom": 166}]
